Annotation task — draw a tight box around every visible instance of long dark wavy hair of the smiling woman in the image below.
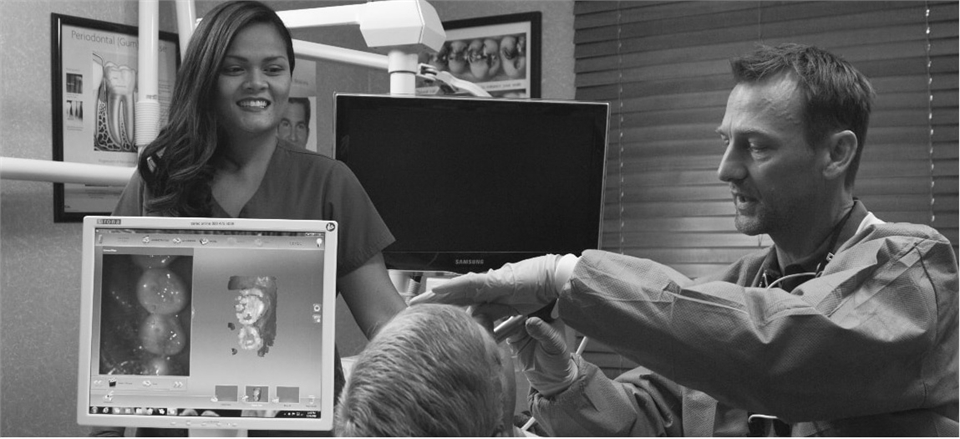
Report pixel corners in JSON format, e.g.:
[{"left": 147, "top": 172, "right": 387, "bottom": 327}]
[{"left": 137, "top": 1, "right": 294, "bottom": 216}]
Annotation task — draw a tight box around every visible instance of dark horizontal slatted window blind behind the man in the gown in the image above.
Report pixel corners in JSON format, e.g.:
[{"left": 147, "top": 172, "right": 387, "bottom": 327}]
[{"left": 574, "top": 1, "right": 960, "bottom": 376}]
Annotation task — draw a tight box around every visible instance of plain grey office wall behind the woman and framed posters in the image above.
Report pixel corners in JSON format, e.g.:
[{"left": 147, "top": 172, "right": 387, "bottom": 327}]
[{"left": 0, "top": 0, "right": 574, "bottom": 436}]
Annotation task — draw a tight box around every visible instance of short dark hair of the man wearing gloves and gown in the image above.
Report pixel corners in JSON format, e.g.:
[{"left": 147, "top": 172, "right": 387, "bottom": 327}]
[{"left": 730, "top": 43, "right": 874, "bottom": 187}]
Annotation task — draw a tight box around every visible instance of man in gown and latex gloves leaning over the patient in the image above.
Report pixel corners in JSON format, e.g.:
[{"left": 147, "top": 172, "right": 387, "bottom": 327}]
[{"left": 412, "top": 44, "right": 958, "bottom": 436}]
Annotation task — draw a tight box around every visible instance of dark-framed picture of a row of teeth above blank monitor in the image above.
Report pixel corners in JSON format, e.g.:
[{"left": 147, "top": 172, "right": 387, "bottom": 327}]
[{"left": 417, "top": 12, "right": 541, "bottom": 98}]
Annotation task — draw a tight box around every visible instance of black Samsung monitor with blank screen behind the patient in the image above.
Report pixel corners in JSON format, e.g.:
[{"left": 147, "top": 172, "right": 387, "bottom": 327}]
[{"left": 335, "top": 94, "right": 609, "bottom": 273}]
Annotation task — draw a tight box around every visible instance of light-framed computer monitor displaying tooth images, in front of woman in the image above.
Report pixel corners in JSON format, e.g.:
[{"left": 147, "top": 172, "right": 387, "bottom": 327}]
[{"left": 77, "top": 216, "right": 338, "bottom": 431}]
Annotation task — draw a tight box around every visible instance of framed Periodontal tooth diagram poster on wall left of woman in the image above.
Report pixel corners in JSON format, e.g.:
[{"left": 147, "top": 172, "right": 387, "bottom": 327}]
[{"left": 51, "top": 14, "right": 179, "bottom": 222}]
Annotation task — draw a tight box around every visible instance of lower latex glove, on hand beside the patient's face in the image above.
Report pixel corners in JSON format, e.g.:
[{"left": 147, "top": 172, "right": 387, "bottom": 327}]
[{"left": 507, "top": 317, "right": 579, "bottom": 397}]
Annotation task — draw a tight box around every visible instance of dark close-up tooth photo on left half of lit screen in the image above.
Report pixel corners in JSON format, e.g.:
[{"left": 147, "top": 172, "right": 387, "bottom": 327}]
[{"left": 100, "top": 254, "right": 193, "bottom": 376}]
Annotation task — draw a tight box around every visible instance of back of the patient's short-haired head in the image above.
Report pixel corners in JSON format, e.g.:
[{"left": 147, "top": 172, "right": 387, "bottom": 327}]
[{"left": 335, "top": 305, "right": 512, "bottom": 437}]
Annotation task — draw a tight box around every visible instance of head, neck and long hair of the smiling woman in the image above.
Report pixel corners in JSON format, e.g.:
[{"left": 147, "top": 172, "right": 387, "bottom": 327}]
[{"left": 121, "top": 2, "right": 295, "bottom": 220}]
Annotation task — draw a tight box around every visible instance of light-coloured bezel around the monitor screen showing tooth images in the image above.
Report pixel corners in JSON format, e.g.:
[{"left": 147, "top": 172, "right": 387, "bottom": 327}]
[{"left": 77, "top": 216, "right": 339, "bottom": 432}]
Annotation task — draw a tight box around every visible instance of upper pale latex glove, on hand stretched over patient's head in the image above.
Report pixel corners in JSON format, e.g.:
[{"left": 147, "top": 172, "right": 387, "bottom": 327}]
[{"left": 410, "top": 255, "right": 578, "bottom": 319}]
